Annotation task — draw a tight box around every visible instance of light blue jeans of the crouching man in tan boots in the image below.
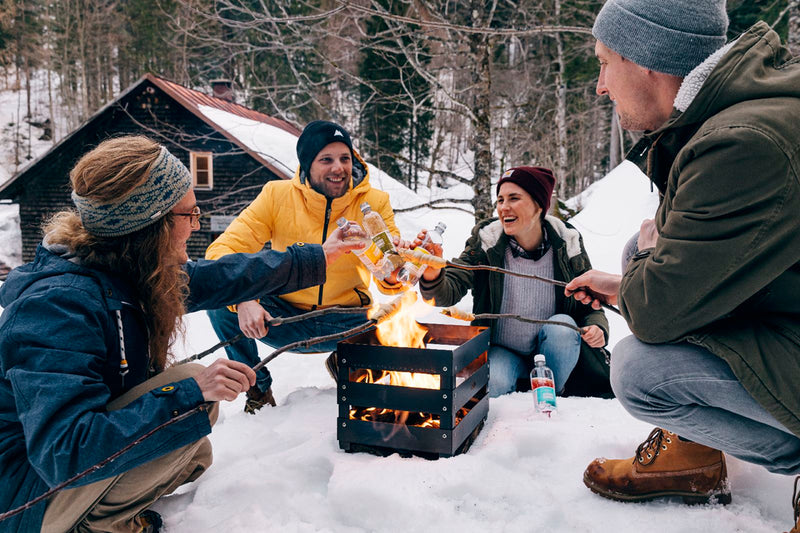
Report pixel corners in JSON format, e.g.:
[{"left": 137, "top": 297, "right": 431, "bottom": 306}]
[{"left": 611, "top": 336, "right": 800, "bottom": 474}]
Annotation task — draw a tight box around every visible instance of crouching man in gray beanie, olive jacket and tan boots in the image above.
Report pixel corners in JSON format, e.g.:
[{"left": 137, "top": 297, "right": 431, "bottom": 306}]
[{"left": 567, "top": 0, "right": 800, "bottom": 527}]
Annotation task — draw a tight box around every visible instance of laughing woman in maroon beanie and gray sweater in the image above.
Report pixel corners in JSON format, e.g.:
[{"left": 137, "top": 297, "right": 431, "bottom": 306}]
[{"left": 420, "top": 167, "right": 611, "bottom": 397}]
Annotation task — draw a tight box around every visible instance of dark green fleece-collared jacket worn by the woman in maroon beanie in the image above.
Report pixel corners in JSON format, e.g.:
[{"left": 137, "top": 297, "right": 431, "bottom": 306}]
[{"left": 420, "top": 216, "right": 611, "bottom": 396}]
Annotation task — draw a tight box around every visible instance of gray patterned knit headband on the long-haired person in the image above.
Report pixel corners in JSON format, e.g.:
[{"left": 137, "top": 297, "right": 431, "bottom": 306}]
[{"left": 72, "top": 146, "right": 192, "bottom": 237}]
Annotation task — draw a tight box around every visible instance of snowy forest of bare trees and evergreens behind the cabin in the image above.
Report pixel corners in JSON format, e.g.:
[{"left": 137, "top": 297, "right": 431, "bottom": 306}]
[{"left": 0, "top": 0, "right": 800, "bottom": 219}]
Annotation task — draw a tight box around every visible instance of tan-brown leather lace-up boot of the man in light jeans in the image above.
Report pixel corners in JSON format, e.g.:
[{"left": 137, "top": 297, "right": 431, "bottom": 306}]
[{"left": 583, "top": 428, "right": 731, "bottom": 504}]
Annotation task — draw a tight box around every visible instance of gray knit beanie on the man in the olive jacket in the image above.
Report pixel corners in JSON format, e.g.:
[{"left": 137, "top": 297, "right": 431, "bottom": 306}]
[{"left": 592, "top": 0, "right": 728, "bottom": 77}]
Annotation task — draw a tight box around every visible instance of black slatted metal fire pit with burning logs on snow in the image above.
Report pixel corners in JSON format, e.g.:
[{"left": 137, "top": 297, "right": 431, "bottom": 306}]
[{"left": 337, "top": 324, "right": 489, "bottom": 458}]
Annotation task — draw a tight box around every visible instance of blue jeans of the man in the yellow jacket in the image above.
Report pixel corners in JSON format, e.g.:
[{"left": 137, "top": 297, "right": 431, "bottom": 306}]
[{"left": 207, "top": 296, "right": 367, "bottom": 392}]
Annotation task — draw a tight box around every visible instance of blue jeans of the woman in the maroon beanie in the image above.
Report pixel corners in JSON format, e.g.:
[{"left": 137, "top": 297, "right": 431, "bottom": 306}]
[{"left": 489, "top": 315, "right": 581, "bottom": 398}]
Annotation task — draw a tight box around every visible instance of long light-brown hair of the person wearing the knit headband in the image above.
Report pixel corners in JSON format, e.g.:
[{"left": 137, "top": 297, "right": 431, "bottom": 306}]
[{"left": 43, "top": 136, "right": 188, "bottom": 371}]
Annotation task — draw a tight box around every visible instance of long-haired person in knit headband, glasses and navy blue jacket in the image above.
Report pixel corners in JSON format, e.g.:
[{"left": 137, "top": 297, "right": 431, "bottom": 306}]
[{"left": 0, "top": 137, "right": 357, "bottom": 532}]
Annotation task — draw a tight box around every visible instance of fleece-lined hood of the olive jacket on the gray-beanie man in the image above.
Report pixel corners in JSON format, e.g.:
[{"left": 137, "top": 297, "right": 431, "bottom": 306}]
[{"left": 650, "top": 22, "right": 800, "bottom": 137}]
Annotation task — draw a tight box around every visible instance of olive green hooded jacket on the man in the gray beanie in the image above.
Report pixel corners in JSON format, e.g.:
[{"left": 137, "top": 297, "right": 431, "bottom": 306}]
[{"left": 619, "top": 22, "right": 800, "bottom": 436}]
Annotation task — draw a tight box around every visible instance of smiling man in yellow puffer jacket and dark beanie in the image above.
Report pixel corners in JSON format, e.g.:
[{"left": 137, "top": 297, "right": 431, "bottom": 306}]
[{"left": 206, "top": 120, "right": 402, "bottom": 413}]
